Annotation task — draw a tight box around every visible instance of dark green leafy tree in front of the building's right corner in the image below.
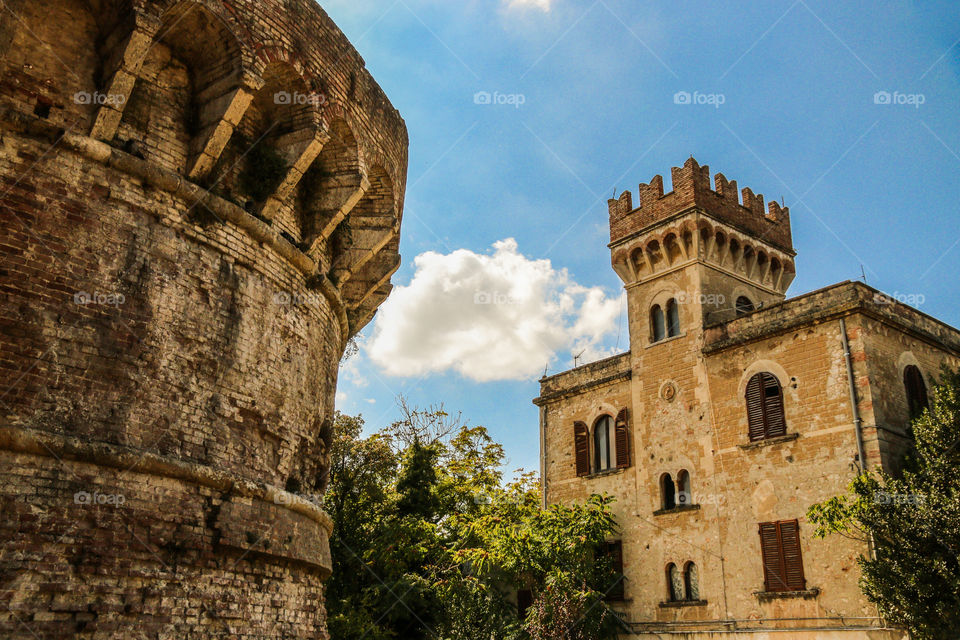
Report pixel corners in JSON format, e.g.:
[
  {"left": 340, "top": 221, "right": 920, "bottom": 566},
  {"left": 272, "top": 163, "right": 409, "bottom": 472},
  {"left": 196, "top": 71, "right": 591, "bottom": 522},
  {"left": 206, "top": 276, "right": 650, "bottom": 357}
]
[{"left": 808, "top": 370, "right": 960, "bottom": 640}]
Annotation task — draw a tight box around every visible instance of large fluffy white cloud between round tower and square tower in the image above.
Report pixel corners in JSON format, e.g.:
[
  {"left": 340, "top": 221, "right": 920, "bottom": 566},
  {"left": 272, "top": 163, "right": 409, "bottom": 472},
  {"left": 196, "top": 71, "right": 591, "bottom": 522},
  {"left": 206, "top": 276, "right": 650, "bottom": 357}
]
[{"left": 365, "top": 238, "right": 621, "bottom": 382}]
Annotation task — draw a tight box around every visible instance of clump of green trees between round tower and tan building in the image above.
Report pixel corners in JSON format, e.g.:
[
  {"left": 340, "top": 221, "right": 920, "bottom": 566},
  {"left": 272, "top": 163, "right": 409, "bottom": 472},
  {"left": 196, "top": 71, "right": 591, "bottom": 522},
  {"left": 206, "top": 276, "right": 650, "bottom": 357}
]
[{"left": 325, "top": 399, "right": 616, "bottom": 640}]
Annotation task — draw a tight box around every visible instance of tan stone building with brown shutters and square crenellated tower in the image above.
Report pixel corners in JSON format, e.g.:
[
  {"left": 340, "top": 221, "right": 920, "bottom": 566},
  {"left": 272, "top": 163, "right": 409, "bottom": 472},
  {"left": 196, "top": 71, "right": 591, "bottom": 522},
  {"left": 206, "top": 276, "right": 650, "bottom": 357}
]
[{"left": 534, "top": 158, "right": 960, "bottom": 640}]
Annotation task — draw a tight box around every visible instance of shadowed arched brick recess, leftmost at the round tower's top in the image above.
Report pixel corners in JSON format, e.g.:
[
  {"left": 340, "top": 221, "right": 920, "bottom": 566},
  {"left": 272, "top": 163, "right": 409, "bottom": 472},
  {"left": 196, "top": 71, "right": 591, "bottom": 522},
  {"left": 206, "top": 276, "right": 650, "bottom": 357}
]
[{"left": 0, "top": 0, "right": 103, "bottom": 128}]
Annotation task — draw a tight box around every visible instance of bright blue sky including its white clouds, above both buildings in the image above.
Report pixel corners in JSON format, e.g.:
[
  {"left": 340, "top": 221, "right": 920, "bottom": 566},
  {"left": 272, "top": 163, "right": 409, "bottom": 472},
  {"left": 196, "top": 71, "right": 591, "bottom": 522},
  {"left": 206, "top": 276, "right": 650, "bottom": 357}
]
[{"left": 321, "top": 0, "right": 960, "bottom": 476}]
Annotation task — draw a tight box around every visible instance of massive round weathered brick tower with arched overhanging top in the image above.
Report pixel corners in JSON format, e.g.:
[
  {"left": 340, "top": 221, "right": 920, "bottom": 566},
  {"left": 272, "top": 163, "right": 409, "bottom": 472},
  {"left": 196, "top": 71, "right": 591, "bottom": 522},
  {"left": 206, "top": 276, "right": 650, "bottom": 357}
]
[{"left": 0, "top": 0, "right": 407, "bottom": 639}]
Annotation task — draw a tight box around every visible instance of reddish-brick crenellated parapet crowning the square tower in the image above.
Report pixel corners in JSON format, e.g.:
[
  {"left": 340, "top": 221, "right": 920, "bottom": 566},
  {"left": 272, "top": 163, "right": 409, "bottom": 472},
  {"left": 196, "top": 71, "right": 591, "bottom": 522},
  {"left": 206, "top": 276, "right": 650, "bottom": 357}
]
[{"left": 607, "top": 157, "right": 793, "bottom": 251}]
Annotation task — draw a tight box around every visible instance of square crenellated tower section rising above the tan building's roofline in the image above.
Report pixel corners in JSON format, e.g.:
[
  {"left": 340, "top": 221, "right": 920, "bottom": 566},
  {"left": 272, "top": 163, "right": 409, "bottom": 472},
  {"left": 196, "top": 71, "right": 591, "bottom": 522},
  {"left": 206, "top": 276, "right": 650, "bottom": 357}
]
[{"left": 608, "top": 158, "right": 796, "bottom": 350}]
